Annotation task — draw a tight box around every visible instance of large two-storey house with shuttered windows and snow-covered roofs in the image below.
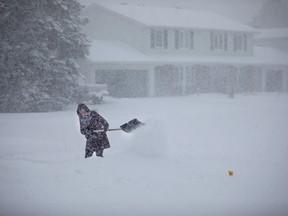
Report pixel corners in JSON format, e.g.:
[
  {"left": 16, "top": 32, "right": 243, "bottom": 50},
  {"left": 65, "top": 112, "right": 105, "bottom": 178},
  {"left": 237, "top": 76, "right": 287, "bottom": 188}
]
[{"left": 81, "top": 4, "right": 288, "bottom": 97}]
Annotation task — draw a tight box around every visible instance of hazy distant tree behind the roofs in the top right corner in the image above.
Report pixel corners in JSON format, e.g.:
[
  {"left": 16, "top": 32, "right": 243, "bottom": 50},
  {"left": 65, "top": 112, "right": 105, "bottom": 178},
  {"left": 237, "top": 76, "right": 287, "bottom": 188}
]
[{"left": 250, "top": 0, "right": 288, "bottom": 28}]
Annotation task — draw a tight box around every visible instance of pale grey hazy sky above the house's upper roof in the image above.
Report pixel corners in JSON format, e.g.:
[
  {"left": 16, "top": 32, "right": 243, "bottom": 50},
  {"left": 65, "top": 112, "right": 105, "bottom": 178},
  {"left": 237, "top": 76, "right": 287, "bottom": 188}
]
[{"left": 78, "top": 0, "right": 266, "bottom": 23}]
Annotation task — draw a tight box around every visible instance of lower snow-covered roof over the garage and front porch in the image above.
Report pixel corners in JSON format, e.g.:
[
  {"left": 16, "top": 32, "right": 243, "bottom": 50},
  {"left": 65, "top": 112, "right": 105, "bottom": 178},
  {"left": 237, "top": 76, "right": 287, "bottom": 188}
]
[{"left": 88, "top": 40, "right": 288, "bottom": 65}]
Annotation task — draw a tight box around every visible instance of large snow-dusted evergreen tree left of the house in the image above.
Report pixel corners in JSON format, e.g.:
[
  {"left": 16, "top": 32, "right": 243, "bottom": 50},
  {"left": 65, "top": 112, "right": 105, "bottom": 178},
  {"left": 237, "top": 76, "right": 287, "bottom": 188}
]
[{"left": 0, "top": 0, "right": 88, "bottom": 112}]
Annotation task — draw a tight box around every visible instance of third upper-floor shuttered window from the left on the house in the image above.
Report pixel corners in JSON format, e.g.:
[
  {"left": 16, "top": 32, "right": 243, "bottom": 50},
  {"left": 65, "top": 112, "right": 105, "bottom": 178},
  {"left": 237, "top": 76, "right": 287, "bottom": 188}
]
[{"left": 210, "top": 32, "right": 228, "bottom": 51}]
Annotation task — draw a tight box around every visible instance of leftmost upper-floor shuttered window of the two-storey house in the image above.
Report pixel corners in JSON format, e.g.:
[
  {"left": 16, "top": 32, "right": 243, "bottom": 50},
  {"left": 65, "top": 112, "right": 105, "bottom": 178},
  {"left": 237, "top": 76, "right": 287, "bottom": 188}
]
[{"left": 151, "top": 29, "right": 168, "bottom": 49}]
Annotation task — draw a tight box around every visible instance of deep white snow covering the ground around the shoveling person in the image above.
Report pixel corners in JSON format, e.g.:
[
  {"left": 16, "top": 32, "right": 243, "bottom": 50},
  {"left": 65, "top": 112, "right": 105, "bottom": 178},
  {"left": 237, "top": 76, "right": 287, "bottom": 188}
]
[{"left": 0, "top": 93, "right": 288, "bottom": 216}]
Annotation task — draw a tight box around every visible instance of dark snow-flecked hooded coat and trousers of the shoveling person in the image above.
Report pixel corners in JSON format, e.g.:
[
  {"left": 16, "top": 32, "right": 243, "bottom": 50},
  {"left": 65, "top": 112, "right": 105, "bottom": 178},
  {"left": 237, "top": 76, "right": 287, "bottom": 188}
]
[{"left": 77, "top": 104, "right": 110, "bottom": 158}]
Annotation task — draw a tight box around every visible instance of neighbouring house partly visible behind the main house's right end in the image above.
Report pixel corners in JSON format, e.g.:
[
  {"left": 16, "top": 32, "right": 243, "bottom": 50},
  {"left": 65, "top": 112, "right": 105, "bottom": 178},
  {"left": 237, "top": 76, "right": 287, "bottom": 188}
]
[{"left": 254, "top": 28, "right": 288, "bottom": 53}]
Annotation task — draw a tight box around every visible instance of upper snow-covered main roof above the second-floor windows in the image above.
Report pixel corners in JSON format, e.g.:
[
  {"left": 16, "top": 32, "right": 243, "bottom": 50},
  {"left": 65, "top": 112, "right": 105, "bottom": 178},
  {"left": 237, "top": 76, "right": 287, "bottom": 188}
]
[{"left": 89, "top": 3, "right": 256, "bottom": 32}]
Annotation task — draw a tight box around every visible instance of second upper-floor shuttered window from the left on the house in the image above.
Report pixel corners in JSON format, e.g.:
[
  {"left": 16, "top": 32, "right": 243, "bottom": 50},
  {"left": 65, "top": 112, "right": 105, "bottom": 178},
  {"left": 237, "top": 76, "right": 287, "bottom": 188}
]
[{"left": 175, "top": 30, "right": 194, "bottom": 49}]
